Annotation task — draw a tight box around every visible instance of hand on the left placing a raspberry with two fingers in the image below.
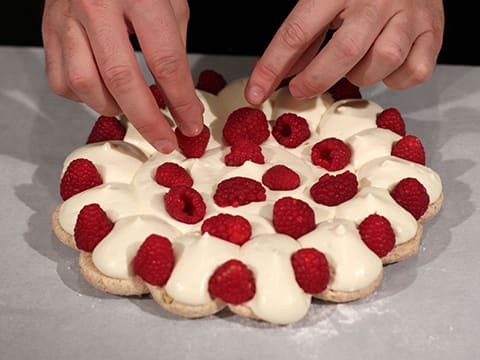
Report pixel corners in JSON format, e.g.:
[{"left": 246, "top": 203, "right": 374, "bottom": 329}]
[{"left": 42, "top": 0, "right": 204, "bottom": 153}]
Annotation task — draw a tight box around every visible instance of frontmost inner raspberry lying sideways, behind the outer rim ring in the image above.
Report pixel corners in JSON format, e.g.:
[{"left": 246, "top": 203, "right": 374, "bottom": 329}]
[{"left": 201, "top": 214, "right": 252, "bottom": 245}]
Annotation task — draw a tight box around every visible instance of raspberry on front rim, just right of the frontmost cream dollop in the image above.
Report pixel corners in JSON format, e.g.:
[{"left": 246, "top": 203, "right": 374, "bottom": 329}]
[{"left": 290, "top": 248, "right": 330, "bottom": 294}]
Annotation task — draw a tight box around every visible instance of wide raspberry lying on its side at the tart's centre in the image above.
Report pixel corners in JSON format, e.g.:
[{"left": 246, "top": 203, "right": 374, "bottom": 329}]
[{"left": 213, "top": 176, "right": 267, "bottom": 207}]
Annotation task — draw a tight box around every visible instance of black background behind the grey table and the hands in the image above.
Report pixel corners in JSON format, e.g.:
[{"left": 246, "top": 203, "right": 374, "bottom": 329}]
[{"left": 0, "top": 0, "right": 480, "bottom": 65}]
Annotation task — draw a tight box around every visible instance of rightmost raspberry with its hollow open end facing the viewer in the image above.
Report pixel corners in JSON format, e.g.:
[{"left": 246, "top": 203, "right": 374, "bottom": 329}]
[{"left": 311, "top": 138, "right": 352, "bottom": 171}]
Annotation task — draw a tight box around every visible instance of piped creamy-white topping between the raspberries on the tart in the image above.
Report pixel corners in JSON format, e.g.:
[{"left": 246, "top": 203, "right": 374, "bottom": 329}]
[{"left": 55, "top": 79, "right": 442, "bottom": 324}]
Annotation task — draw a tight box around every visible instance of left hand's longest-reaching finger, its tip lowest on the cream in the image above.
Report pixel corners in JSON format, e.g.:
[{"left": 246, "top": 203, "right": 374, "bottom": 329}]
[{"left": 79, "top": 2, "right": 176, "bottom": 152}]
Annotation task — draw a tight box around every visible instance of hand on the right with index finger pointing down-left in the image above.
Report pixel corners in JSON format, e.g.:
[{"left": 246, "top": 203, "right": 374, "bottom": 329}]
[{"left": 245, "top": 0, "right": 444, "bottom": 105}]
